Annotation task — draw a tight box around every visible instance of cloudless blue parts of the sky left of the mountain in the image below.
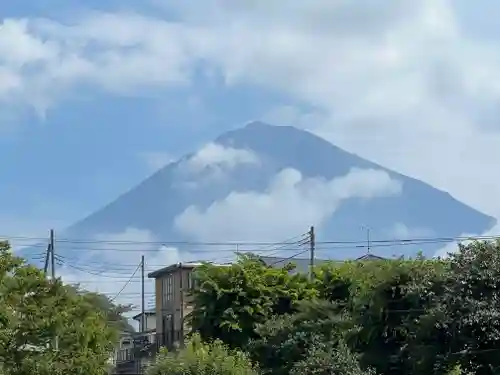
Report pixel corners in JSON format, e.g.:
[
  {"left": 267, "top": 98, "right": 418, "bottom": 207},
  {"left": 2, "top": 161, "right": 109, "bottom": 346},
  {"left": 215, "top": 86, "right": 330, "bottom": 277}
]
[{"left": 0, "top": 1, "right": 308, "bottom": 234}]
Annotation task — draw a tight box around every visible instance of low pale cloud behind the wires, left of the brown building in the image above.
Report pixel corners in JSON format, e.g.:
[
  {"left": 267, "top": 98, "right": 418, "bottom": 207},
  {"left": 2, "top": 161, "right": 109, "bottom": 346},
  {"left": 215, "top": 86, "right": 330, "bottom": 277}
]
[{"left": 56, "top": 228, "right": 187, "bottom": 315}]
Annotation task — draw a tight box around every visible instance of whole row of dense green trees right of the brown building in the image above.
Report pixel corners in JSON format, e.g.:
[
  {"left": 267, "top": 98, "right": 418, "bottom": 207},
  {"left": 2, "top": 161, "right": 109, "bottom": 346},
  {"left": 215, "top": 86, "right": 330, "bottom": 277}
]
[{"left": 184, "top": 241, "right": 500, "bottom": 375}]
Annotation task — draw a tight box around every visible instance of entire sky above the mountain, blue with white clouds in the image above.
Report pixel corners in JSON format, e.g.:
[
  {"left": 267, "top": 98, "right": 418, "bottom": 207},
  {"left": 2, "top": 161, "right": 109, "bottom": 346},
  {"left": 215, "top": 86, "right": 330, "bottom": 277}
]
[{"left": 0, "top": 0, "right": 500, "bottom": 241}]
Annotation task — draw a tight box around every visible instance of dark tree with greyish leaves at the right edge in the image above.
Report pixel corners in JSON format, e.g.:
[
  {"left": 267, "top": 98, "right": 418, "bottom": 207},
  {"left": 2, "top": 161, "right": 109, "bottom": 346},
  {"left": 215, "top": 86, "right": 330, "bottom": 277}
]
[{"left": 412, "top": 240, "right": 500, "bottom": 375}]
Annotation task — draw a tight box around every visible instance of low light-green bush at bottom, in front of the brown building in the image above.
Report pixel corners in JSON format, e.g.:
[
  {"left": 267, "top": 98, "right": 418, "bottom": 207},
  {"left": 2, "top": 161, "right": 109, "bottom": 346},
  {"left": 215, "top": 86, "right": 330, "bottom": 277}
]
[{"left": 147, "top": 335, "right": 258, "bottom": 375}]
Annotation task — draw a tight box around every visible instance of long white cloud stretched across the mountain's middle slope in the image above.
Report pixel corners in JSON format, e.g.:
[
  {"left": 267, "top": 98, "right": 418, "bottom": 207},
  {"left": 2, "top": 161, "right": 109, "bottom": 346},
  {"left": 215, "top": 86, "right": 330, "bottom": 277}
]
[{"left": 175, "top": 169, "right": 402, "bottom": 241}]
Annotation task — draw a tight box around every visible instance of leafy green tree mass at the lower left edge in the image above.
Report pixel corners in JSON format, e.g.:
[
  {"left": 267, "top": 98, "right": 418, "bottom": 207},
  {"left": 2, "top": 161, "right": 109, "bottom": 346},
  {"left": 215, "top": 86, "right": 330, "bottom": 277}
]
[{"left": 0, "top": 242, "right": 117, "bottom": 375}]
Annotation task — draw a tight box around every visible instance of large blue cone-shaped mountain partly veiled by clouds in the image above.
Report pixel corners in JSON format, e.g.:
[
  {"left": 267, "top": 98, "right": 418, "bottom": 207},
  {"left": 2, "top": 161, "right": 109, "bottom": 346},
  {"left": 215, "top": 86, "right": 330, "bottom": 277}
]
[{"left": 61, "top": 122, "right": 495, "bottom": 258}]
